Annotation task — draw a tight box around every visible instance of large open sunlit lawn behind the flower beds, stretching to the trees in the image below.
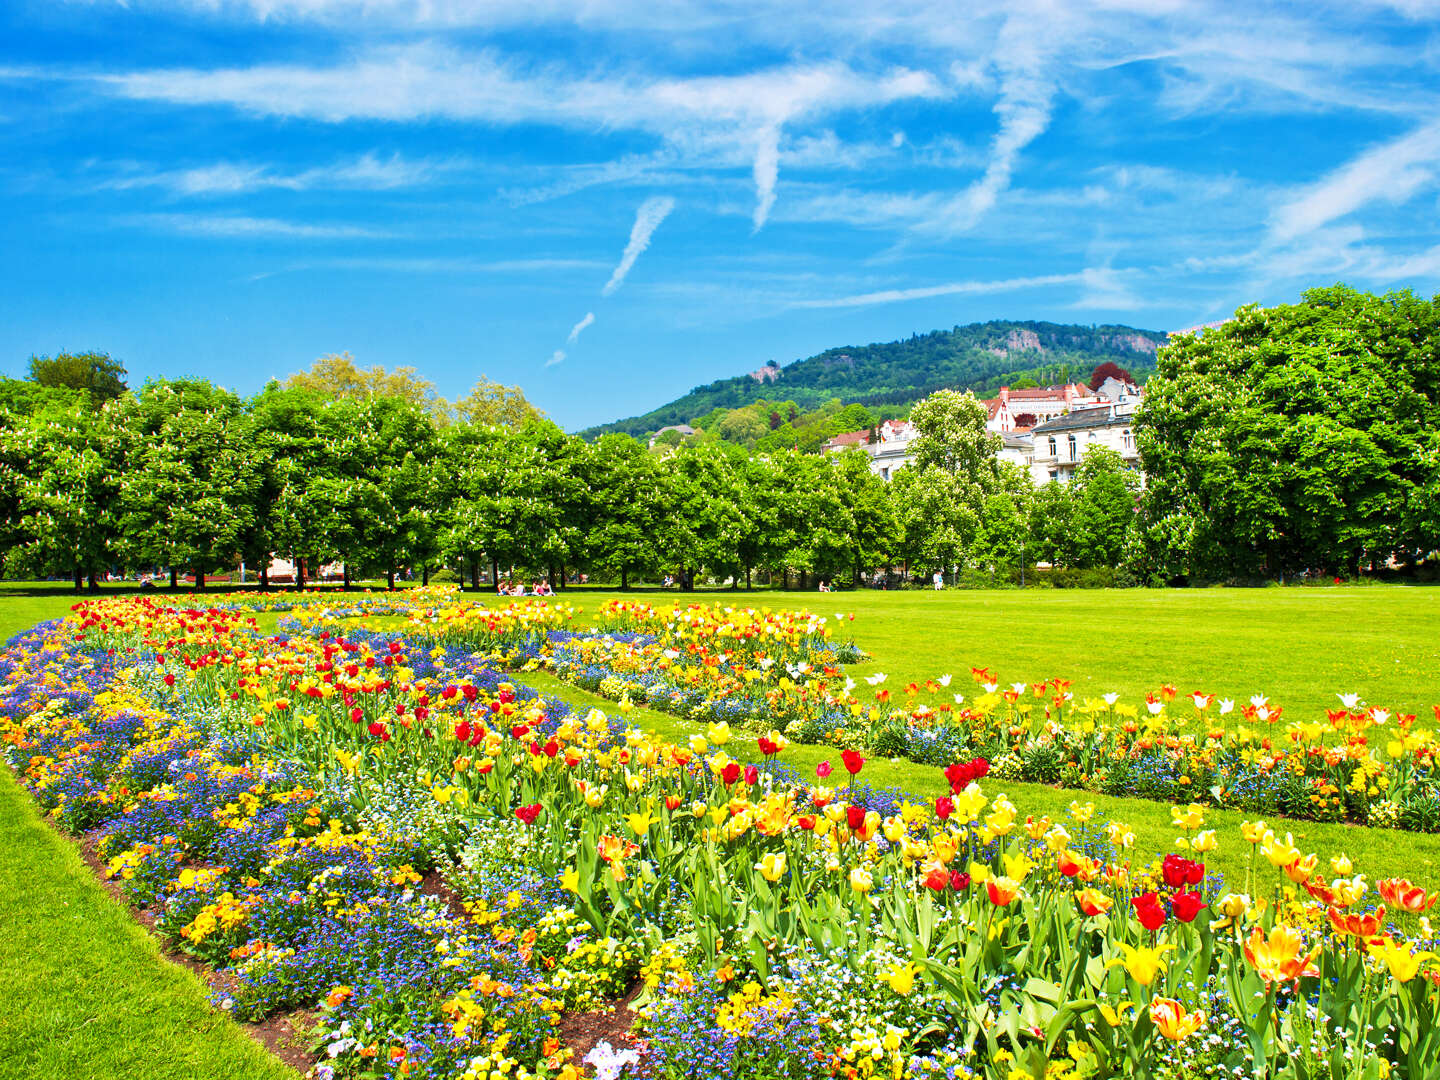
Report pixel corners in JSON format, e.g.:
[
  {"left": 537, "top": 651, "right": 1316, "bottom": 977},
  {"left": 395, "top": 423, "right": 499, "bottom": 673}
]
[{"left": 547, "top": 586, "right": 1440, "bottom": 720}]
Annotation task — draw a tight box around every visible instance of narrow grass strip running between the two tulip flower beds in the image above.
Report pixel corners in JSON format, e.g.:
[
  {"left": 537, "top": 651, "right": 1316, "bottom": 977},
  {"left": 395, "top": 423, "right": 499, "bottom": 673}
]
[{"left": 517, "top": 671, "right": 1440, "bottom": 891}]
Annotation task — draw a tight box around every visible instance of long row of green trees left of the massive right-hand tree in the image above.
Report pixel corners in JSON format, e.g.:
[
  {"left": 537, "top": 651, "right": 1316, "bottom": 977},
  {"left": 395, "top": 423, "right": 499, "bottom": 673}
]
[{"left": 0, "top": 368, "right": 1135, "bottom": 588}]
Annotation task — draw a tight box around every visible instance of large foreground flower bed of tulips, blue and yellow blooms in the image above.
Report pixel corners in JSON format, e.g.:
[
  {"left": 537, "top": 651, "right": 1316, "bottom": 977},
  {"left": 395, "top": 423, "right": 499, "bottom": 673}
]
[{"left": 8, "top": 602, "right": 1440, "bottom": 1080}]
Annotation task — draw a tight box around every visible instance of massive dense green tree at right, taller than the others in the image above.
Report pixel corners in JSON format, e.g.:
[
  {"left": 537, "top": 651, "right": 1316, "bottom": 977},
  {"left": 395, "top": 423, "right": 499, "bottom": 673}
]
[{"left": 1136, "top": 285, "right": 1440, "bottom": 577}]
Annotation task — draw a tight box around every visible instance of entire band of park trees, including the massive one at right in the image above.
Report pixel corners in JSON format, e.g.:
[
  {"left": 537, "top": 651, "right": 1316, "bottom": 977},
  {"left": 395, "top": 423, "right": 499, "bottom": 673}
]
[{"left": 0, "top": 287, "right": 1440, "bottom": 588}]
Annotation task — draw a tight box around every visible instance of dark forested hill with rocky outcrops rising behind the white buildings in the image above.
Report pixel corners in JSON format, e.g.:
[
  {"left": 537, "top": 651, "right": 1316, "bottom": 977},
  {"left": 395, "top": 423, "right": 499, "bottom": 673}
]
[{"left": 580, "top": 321, "right": 1166, "bottom": 438}]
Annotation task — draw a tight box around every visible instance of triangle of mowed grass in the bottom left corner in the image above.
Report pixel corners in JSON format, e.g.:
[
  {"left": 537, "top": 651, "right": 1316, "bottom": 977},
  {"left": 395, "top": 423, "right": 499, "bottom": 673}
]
[{"left": 0, "top": 769, "right": 298, "bottom": 1080}]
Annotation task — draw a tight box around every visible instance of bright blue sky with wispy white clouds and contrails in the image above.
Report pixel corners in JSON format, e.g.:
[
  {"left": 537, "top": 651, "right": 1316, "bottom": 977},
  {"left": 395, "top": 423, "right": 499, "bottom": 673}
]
[{"left": 0, "top": 0, "right": 1440, "bottom": 429}]
